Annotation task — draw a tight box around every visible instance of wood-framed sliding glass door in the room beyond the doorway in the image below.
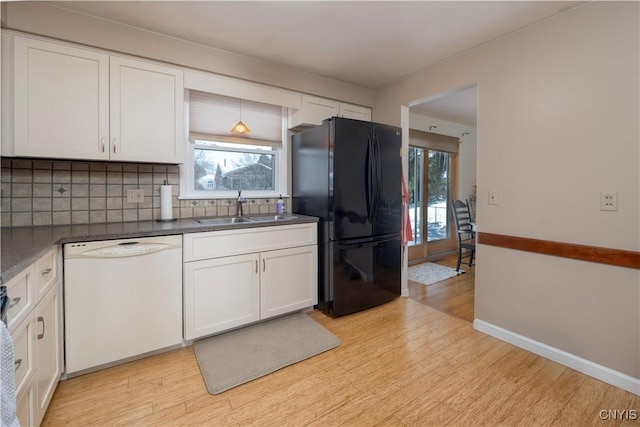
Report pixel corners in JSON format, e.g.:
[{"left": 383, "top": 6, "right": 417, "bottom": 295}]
[{"left": 408, "top": 146, "right": 457, "bottom": 260}]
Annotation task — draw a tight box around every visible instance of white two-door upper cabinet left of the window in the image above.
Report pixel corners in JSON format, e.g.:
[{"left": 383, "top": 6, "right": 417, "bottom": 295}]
[{"left": 2, "top": 36, "right": 184, "bottom": 164}]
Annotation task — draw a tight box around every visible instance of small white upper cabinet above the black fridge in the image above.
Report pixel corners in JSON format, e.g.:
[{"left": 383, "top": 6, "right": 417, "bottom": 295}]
[{"left": 289, "top": 95, "right": 371, "bottom": 129}]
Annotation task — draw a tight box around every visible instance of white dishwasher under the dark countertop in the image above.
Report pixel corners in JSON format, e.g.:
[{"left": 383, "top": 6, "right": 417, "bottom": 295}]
[{"left": 64, "top": 236, "right": 182, "bottom": 375}]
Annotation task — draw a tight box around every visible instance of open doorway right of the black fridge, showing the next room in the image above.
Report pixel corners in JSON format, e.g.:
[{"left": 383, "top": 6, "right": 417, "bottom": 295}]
[{"left": 401, "top": 84, "right": 478, "bottom": 321}]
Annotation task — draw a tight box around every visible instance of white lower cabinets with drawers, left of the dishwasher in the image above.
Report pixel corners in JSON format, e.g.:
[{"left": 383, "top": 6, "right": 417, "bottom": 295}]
[{"left": 7, "top": 247, "right": 62, "bottom": 426}]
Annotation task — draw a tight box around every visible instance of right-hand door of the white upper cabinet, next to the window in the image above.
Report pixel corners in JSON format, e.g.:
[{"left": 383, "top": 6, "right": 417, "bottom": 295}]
[{"left": 110, "top": 57, "right": 184, "bottom": 163}]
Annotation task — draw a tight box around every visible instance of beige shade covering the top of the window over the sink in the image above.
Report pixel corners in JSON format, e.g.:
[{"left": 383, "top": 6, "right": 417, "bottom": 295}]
[{"left": 189, "top": 90, "right": 282, "bottom": 147}]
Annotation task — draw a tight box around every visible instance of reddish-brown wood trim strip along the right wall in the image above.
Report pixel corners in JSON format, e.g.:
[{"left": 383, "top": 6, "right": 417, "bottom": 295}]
[{"left": 478, "top": 232, "right": 640, "bottom": 269}]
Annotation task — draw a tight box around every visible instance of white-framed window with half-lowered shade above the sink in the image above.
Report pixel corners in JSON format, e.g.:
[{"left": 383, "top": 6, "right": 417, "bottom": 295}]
[{"left": 180, "top": 91, "right": 287, "bottom": 198}]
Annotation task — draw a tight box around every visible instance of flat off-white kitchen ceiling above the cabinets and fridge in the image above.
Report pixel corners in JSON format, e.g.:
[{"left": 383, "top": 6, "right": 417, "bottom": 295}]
[{"left": 49, "top": 1, "right": 584, "bottom": 124}]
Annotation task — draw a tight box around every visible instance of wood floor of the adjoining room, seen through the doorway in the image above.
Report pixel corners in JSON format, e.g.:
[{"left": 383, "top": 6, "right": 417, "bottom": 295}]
[{"left": 408, "top": 255, "right": 476, "bottom": 322}]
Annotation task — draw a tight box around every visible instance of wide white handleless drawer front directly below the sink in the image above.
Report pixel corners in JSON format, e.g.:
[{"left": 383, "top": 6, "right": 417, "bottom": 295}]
[{"left": 183, "top": 223, "right": 317, "bottom": 262}]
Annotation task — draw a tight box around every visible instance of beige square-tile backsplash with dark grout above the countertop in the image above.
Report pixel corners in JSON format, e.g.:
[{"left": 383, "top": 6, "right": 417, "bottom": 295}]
[{"left": 0, "top": 158, "right": 277, "bottom": 227}]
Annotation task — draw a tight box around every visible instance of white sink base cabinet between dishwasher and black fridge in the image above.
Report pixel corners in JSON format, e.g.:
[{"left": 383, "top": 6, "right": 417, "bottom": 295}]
[{"left": 184, "top": 223, "right": 318, "bottom": 340}]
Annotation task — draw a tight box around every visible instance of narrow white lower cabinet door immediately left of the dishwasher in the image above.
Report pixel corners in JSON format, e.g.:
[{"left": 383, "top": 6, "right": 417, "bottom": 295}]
[{"left": 35, "top": 284, "right": 62, "bottom": 424}]
